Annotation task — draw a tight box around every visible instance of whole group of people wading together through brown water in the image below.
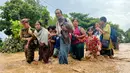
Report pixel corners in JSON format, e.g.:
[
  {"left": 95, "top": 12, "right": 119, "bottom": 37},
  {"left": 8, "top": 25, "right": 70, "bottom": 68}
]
[{"left": 20, "top": 9, "right": 118, "bottom": 64}]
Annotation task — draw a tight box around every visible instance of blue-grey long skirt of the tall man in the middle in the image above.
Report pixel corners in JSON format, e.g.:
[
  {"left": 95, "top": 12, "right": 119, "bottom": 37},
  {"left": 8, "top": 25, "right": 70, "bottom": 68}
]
[{"left": 59, "top": 38, "right": 70, "bottom": 64}]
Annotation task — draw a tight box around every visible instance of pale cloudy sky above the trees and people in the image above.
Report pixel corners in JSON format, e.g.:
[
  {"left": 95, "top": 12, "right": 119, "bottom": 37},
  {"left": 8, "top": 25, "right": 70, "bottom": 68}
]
[{"left": 0, "top": 0, "right": 130, "bottom": 37}]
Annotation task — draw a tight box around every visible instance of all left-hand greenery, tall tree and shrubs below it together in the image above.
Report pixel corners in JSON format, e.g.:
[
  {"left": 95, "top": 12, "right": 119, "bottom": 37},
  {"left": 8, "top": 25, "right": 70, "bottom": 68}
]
[{"left": 0, "top": 0, "right": 49, "bottom": 53}]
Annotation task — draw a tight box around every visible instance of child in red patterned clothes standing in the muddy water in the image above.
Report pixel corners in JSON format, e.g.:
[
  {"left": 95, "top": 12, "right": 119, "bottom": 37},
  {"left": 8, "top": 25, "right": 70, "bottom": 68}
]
[{"left": 86, "top": 27, "right": 101, "bottom": 58}]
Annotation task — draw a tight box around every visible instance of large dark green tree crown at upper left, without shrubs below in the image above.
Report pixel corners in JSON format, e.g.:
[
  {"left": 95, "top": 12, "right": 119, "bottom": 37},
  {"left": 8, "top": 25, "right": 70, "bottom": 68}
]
[{"left": 0, "top": 0, "right": 49, "bottom": 35}]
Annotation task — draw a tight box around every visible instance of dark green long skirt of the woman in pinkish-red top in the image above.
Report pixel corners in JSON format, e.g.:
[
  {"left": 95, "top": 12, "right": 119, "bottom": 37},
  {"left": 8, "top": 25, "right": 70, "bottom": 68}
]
[{"left": 71, "top": 43, "right": 84, "bottom": 60}]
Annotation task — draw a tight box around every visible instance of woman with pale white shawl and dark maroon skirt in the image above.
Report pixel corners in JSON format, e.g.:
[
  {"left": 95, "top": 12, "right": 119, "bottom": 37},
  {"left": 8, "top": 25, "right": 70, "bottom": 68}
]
[{"left": 35, "top": 21, "right": 49, "bottom": 63}]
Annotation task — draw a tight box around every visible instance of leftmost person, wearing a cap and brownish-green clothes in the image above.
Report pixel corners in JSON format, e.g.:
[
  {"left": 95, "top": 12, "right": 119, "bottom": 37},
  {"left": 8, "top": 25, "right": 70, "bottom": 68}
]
[{"left": 20, "top": 18, "right": 38, "bottom": 63}]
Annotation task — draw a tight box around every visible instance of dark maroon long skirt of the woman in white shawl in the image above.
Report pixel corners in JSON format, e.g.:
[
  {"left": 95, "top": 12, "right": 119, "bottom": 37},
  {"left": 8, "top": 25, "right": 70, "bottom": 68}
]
[{"left": 39, "top": 45, "right": 49, "bottom": 63}]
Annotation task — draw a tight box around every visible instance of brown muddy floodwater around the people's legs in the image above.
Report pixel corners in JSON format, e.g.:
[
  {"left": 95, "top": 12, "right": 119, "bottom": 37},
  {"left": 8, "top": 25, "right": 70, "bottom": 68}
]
[{"left": 0, "top": 44, "right": 130, "bottom": 73}]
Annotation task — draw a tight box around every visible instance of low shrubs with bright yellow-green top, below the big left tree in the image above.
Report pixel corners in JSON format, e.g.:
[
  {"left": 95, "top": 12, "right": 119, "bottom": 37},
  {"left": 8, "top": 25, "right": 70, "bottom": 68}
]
[{"left": 0, "top": 20, "right": 23, "bottom": 53}]
